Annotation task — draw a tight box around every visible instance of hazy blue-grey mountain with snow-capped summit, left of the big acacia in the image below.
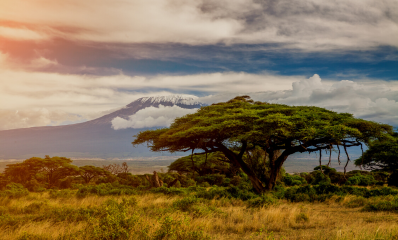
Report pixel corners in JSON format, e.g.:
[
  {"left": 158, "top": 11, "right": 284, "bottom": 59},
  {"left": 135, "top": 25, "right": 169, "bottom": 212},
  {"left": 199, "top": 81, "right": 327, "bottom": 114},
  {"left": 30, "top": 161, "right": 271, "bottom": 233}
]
[{"left": 0, "top": 95, "right": 205, "bottom": 159}]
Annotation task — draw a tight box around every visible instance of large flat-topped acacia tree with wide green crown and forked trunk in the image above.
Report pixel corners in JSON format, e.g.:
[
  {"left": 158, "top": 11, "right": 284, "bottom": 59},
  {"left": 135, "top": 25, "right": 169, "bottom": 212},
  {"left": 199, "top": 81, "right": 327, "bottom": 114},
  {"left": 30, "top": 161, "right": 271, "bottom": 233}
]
[{"left": 133, "top": 96, "right": 392, "bottom": 193}]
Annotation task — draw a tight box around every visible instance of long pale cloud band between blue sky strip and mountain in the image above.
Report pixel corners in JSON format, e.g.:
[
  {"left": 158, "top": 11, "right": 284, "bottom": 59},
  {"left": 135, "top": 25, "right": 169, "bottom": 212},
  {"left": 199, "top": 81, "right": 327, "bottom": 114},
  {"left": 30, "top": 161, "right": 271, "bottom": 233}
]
[{"left": 0, "top": 52, "right": 398, "bottom": 129}]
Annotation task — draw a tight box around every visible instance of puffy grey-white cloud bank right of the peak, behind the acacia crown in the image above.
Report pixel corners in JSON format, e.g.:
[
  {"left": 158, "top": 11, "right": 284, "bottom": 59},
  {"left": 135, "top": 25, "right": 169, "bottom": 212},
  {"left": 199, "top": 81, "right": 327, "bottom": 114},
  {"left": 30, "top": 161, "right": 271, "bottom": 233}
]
[{"left": 197, "top": 74, "right": 398, "bottom": 126}]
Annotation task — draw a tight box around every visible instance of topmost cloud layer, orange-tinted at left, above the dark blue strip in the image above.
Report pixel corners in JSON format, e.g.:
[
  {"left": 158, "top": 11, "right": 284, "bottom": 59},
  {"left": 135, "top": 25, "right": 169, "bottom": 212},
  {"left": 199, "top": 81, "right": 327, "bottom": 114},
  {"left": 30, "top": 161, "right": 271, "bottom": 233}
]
[{"left": 0, "top": 0, "right": 398, "bottom": 51}]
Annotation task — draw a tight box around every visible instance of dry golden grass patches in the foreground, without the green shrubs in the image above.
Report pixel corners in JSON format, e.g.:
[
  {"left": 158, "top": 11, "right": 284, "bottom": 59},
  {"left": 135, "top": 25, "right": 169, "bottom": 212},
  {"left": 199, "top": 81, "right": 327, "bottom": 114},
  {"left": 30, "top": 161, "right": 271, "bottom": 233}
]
[{"left": 0, "top": 193, "right": 398, "bottom": 240}]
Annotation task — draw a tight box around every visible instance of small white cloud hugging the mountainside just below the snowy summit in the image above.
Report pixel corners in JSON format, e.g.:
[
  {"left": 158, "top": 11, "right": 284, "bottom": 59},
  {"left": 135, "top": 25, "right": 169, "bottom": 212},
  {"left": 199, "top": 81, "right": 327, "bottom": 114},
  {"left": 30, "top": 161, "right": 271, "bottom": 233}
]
[{"left": 112, "top": 105, "right": 198, "bottom": 130}]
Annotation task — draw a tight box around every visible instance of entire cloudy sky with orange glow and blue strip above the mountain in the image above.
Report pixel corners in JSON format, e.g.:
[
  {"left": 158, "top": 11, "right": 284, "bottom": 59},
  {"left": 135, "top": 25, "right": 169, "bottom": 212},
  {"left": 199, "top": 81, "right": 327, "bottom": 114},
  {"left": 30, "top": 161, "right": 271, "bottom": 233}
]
[{"left": 0, "top": 0, "right": 398, "bottom": 130}]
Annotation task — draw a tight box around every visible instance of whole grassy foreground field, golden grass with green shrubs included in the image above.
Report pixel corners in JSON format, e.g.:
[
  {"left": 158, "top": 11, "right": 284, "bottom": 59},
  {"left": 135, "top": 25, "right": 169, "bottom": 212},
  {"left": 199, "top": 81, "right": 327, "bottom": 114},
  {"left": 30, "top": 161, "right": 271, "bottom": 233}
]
[{"left": 0, "top": 190, "right": 398, "bottom": 240}]
